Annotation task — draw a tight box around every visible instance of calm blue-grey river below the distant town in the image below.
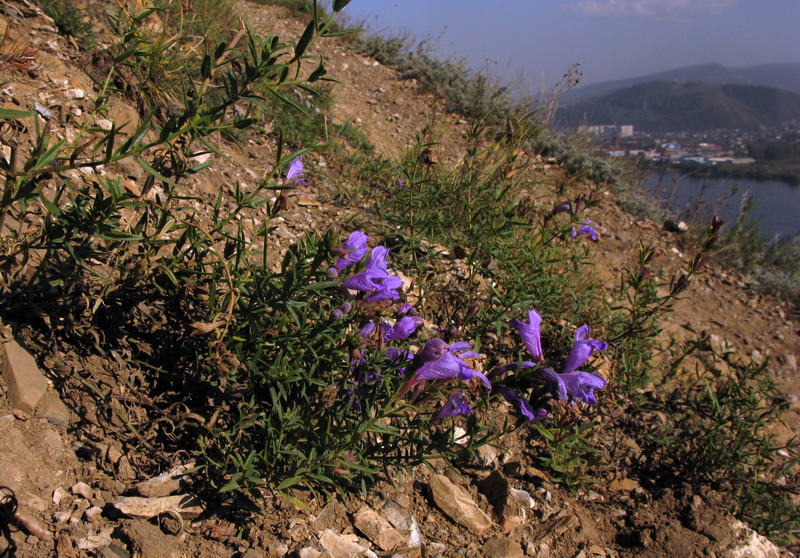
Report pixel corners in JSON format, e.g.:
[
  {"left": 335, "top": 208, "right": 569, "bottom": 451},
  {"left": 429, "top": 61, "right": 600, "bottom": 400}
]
[{"left": 643, "top": 169, "right": 800, "bottom": 239}]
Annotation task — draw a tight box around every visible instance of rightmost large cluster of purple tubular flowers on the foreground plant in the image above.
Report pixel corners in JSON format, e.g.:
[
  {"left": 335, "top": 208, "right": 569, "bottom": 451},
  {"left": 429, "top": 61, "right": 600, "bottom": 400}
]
[{"left": 497, "top": 310, "right": 608, "bottom": 420}]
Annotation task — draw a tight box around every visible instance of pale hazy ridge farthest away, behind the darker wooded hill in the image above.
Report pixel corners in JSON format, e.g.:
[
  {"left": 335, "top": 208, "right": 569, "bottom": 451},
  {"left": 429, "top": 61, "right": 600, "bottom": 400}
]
[{"left": 561, "top": 63, "right": 800, "bottom": 106}]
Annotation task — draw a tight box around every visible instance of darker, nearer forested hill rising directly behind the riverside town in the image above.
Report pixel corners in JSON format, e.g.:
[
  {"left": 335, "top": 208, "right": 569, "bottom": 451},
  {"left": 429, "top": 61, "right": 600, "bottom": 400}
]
[{"left": 556, "top": 81, "right": 800, "bottom": 133}]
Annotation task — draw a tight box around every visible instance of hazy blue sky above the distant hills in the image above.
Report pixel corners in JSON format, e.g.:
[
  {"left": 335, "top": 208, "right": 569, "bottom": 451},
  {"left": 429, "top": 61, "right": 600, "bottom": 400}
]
[{"left": 345, "top": 0, "right": 800, "bottom": 91}]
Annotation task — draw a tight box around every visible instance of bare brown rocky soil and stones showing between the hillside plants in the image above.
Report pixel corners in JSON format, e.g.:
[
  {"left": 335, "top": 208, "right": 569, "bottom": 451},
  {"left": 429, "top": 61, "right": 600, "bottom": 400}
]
[{"left": 0, "top": 0, "right": 800, "bottom": 558}]
